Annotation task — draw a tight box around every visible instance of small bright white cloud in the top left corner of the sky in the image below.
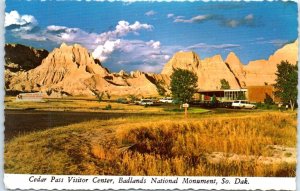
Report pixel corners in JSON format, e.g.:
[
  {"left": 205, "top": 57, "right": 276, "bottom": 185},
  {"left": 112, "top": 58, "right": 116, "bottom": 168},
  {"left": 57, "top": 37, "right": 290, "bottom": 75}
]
[{"left": 4, "top": 10, "right": 38, "bottom": 31}]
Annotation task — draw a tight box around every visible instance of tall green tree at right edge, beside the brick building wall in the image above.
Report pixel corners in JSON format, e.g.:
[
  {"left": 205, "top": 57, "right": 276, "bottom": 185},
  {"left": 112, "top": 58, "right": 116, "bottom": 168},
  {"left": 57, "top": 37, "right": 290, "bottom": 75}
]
[{"left": 275, "top": 61, "right": 298, "bottom": 111}]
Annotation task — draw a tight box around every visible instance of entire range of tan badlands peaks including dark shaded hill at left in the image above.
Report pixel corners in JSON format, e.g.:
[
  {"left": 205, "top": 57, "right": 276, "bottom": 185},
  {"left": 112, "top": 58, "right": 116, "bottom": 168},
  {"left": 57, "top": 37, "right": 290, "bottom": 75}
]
[{"left": 5, "top": 40, "right": 298, "bottom": 96}]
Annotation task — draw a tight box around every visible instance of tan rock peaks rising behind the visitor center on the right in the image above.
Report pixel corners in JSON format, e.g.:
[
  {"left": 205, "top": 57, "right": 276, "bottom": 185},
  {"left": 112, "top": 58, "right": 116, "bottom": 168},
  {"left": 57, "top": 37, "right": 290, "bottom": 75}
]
[{"left": 161, "top": 40, "right": 298, "bottom": 90}]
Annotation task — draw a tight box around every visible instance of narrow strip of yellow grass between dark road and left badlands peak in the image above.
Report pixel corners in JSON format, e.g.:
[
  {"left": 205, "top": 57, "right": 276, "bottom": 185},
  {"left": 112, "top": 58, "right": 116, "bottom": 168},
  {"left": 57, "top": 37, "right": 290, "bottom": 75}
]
[{"left": 5, "top": 96, "right": 208, "bottom": 114}]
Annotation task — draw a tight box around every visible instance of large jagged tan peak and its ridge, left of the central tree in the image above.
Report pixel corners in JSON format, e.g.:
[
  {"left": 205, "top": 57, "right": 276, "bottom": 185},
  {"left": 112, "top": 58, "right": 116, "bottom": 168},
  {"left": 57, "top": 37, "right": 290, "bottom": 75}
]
[{"left": 6, "top": 44, "right": 162, "bottom": 96}]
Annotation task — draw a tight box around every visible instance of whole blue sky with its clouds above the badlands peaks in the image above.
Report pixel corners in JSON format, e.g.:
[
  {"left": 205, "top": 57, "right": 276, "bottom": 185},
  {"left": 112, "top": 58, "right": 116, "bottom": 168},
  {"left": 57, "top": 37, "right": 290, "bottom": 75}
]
[{"left": 5, "top": 0, "right": 298, "bottom": 72}]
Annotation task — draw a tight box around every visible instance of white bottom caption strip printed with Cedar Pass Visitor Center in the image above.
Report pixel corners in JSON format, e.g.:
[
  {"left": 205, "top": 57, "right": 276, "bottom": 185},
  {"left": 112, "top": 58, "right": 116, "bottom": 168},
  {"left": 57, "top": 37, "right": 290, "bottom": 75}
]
[{"left": 4, "top": 174, "right": 296, "bottom": 190}]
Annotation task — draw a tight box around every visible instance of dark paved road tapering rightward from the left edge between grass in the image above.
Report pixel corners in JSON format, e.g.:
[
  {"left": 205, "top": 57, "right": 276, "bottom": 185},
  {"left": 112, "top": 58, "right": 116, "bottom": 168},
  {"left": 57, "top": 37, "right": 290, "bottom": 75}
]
[{"left": 4, "top": 110, "right": 162, "bottom": 141}]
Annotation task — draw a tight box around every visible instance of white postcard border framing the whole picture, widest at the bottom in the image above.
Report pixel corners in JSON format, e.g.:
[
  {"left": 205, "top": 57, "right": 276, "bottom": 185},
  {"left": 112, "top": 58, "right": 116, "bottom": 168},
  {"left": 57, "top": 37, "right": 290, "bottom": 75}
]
[{"left": 0, "top": 0, "right": 300, "bottom": 190}]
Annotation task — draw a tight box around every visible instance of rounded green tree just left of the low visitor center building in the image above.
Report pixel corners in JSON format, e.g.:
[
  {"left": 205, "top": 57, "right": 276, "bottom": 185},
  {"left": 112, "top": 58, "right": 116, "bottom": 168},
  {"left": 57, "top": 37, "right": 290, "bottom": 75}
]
[{"left": 171, "top": 69, "right": 198, "bottom": 103}]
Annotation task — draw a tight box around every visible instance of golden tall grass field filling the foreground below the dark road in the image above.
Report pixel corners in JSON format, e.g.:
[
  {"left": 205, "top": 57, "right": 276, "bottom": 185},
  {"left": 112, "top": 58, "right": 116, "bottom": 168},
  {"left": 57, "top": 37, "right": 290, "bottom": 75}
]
[{"left": 4, "top": 107, "right": 297, "bottom": 176}]
